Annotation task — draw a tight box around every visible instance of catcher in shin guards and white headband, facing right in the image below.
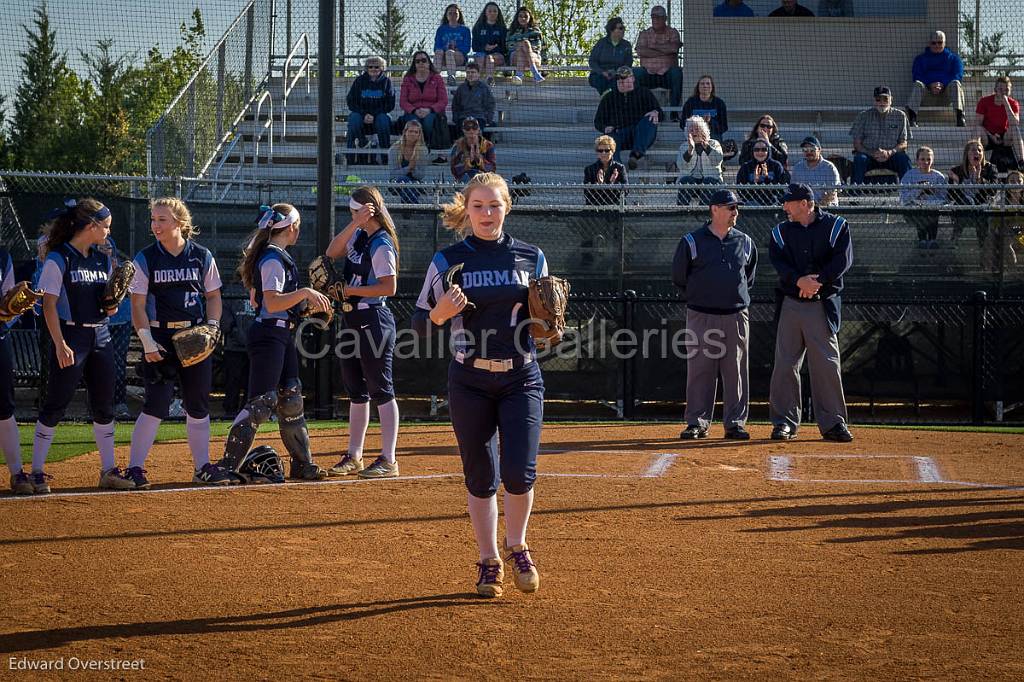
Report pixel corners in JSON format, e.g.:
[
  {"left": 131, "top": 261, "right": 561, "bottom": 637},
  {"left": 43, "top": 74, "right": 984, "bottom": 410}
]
[{"left": 219, "top": 204, "right": 331, "bottom": 480}]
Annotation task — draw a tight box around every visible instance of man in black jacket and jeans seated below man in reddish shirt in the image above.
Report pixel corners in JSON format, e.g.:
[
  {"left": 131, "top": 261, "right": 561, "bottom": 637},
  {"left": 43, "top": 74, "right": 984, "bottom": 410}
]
[{"left": 594, "top": 67, "right": 663, "bottom": 170}]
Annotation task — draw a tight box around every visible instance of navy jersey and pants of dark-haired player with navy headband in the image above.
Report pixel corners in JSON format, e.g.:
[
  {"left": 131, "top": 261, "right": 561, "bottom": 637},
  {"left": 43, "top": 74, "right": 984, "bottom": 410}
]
[{"left": 34, "top": 243, "right": 115, "bottom": 428}]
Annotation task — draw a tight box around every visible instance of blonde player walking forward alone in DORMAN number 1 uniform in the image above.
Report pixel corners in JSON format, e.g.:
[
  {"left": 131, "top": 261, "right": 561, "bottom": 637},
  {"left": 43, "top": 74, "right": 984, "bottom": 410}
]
[{"left": 414, "top": 173, "right": 548, "bottom": 597}]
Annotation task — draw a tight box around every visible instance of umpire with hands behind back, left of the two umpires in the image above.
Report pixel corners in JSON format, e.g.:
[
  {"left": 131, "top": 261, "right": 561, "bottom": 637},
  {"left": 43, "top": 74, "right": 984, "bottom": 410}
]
[{"left": 672, "top": 189, "right": 758, "bottom": 440}]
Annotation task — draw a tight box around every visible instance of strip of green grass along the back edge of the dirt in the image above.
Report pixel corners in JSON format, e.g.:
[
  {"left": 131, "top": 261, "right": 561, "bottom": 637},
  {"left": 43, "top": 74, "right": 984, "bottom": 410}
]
[{"left": 18, "top": 420, "right": 1024, "bottom": 463}]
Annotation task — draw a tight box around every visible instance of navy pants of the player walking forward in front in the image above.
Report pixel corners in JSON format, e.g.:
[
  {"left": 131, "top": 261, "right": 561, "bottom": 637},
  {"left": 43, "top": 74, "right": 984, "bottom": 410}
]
[{"left": 449, "top": 360, "right": 544, "bottom": 498}]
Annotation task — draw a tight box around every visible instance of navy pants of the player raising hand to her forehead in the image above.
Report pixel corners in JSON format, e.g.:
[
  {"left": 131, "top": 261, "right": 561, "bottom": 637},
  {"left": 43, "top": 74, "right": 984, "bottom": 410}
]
[{"left": 341, "top": 305, "right": 395, "bottom": 404}]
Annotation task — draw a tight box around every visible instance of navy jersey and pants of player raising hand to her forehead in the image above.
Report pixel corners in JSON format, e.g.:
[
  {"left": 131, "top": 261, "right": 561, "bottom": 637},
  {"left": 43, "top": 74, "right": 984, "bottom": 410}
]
[{"left": 341, "top": 228, "right": 398, "bottom": 404}]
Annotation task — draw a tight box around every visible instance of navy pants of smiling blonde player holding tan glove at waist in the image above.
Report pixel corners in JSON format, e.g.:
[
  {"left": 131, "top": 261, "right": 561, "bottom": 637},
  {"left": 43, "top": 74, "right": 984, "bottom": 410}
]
[{"left": 142, "top": 329, "right": 213, "bottom": 419}]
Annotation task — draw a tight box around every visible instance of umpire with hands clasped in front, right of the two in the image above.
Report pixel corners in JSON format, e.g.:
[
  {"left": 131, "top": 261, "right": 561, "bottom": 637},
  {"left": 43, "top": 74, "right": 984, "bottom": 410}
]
[{"left": 768, "top": 184, "right": 853, "bottom": 442}]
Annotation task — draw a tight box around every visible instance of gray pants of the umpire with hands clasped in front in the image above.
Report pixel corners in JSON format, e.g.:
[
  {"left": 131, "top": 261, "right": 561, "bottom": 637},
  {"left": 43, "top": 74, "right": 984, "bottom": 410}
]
[{"left": 768, "top": 296, "right": 847, "bottom": 434}]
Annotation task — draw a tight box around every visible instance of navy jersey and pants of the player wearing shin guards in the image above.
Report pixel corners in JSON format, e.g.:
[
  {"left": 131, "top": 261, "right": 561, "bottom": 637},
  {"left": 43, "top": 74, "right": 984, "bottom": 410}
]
[{"left": 249, "top": 244, "right": 305, "bottom": 399}]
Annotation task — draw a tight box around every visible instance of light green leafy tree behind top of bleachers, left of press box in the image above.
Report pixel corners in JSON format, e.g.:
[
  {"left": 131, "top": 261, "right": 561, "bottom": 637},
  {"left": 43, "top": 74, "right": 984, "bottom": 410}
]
[{"left": 524, "top": 0, "right": 633, "bottom": 61}]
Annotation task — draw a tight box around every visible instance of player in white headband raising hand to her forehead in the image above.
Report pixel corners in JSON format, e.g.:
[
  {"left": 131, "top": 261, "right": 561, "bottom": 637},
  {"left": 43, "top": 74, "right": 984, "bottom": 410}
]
[{"left": 327, "top": 186, "right": 398, "bottom": 478}]
